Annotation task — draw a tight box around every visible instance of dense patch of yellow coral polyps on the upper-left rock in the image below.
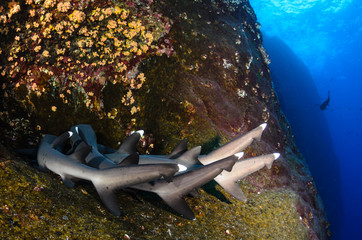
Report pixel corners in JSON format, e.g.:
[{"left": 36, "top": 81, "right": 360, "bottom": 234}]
[{"left": 0, "top": 0, "right": 173, "bottom": 118}]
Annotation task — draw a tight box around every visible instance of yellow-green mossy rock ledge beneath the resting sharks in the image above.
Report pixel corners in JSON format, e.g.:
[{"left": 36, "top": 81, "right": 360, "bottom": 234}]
[{"left": 0, "top": 144, "right": 308, "bottom": 239}]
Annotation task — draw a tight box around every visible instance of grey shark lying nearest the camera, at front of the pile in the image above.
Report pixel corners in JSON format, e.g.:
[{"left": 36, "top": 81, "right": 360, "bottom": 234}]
[{"left": 37, "top": 131, "right": 179, "bottom": 216}]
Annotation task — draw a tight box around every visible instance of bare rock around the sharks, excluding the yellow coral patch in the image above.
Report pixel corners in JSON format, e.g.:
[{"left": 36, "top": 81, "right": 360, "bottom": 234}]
[{"left": 0, "top": 0, "right": 328, "bottom": 239}]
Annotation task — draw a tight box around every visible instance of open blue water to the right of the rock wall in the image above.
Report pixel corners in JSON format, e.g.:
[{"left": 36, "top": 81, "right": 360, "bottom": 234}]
[{"left": 250, "top": 0, "right": 362, "bottom": 239}]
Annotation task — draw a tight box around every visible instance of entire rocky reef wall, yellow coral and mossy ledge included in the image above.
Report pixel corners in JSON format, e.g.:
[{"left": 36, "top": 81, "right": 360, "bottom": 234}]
[{"left": 0, "top": 0, "right": 329, "bottom": 239}]
